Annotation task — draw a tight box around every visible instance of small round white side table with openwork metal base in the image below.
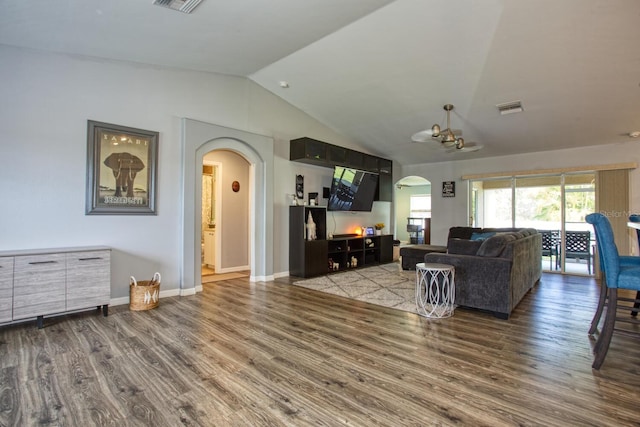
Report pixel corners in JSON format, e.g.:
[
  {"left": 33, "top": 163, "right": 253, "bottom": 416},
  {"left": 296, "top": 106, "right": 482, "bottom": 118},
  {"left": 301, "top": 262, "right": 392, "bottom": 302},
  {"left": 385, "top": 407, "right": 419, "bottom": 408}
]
[{"left": 416, "top": 262, "right": 456, "bottom": 318}]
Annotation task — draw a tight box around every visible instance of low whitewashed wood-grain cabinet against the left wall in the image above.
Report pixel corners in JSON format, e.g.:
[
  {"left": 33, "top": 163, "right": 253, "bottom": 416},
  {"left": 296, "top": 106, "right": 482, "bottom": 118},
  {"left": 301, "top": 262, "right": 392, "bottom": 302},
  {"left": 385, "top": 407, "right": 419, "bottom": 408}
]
[{"left": 0, "top": 246, "right": 111, "bottom": 328}]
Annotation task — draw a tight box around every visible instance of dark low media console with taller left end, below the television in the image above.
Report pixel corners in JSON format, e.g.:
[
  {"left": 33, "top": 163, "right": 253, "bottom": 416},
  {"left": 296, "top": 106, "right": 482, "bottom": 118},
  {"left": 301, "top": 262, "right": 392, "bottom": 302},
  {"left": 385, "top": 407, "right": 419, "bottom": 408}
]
[{"left": 289, "top": 206, "right": 393, "bottom": 277}]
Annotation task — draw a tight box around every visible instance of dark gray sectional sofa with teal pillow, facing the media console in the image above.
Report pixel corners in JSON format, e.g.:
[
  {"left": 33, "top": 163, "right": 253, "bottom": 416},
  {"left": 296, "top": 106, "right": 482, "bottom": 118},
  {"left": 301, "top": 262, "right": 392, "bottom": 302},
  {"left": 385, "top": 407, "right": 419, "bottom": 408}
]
[{"left": 424, "top": 227, "right": 542, "bottom": 319}]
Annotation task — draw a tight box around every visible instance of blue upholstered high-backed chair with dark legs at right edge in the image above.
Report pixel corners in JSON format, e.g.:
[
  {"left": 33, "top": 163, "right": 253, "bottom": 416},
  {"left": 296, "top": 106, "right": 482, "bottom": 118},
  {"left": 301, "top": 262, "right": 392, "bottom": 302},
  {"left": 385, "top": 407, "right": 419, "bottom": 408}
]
[{"left": 586, "top": 213, "right": 640, "bottom": 369}]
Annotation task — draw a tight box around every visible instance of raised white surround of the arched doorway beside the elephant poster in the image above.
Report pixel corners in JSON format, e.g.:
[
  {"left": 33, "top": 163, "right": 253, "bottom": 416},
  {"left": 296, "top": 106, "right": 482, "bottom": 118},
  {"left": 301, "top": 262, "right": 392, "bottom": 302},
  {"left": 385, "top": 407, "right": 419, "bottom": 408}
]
[{"left": 180, "top": 118, "right": 273, "bottom": 295}]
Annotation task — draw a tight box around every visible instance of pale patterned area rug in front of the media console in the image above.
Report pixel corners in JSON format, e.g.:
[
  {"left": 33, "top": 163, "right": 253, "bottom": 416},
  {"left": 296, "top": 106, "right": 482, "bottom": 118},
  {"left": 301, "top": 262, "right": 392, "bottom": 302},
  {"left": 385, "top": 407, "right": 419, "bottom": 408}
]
[{"left": 294, "top": 262, "right": 416, "bottom": 313}]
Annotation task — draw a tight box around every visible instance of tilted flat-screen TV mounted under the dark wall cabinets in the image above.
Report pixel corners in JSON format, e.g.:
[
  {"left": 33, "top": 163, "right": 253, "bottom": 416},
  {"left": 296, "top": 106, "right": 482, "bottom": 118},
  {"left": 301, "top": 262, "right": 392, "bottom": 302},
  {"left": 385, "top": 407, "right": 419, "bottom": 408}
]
[{"left": 327, "top": 166, "right": 378, "bottom": 212}]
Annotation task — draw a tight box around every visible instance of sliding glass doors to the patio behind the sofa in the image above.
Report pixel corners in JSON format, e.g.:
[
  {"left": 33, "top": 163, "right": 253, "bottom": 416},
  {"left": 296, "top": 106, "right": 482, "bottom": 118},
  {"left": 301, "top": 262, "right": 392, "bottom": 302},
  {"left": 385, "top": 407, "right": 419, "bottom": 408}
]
[{"left": 470, "top": 173, "right": 595, "bottom": 275}]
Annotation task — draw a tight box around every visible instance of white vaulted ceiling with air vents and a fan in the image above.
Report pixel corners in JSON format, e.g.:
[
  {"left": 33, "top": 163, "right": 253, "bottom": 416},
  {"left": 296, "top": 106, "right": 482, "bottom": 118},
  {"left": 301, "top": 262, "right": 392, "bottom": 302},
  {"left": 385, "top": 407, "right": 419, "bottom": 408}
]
[{"left": 0, "top": 0, "right": 640, "bottom": 164}]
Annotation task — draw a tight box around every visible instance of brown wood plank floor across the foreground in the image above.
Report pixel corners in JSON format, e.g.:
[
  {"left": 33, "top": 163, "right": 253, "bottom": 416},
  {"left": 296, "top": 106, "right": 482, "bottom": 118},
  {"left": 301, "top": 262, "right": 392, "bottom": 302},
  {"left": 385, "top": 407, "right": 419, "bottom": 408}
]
[{"left": 0, "top": 274, "right": 640, "bottom": 426}]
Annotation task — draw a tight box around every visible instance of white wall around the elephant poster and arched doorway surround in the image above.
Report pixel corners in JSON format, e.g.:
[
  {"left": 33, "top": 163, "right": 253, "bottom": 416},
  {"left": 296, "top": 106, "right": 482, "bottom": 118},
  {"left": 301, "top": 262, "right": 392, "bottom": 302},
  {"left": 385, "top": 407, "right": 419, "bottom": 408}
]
[{"left": 0, "top": 46, "right": 390, "bottom": 298}]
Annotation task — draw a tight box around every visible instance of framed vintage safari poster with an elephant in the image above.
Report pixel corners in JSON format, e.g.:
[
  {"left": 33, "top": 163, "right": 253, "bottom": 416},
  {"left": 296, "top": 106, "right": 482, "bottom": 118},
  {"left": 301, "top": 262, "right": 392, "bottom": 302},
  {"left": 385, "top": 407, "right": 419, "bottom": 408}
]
[{"left": 85, "top": 120, "right": 159, "bottom": 215}]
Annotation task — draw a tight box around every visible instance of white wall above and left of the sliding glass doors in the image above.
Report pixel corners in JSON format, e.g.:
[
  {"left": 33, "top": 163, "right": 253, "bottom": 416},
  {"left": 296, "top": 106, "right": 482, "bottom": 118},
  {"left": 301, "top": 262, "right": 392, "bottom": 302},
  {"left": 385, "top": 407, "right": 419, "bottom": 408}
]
[{"left": 396, "top": 146, "right": 640, "bottom": 245}]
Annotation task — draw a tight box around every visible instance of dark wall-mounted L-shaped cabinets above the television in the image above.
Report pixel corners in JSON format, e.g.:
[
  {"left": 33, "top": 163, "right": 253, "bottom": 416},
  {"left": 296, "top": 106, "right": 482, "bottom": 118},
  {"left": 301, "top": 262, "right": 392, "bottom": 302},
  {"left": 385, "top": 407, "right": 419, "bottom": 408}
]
[{"left": 289, "top": 137, "right": 393, "bottom": 202}]
